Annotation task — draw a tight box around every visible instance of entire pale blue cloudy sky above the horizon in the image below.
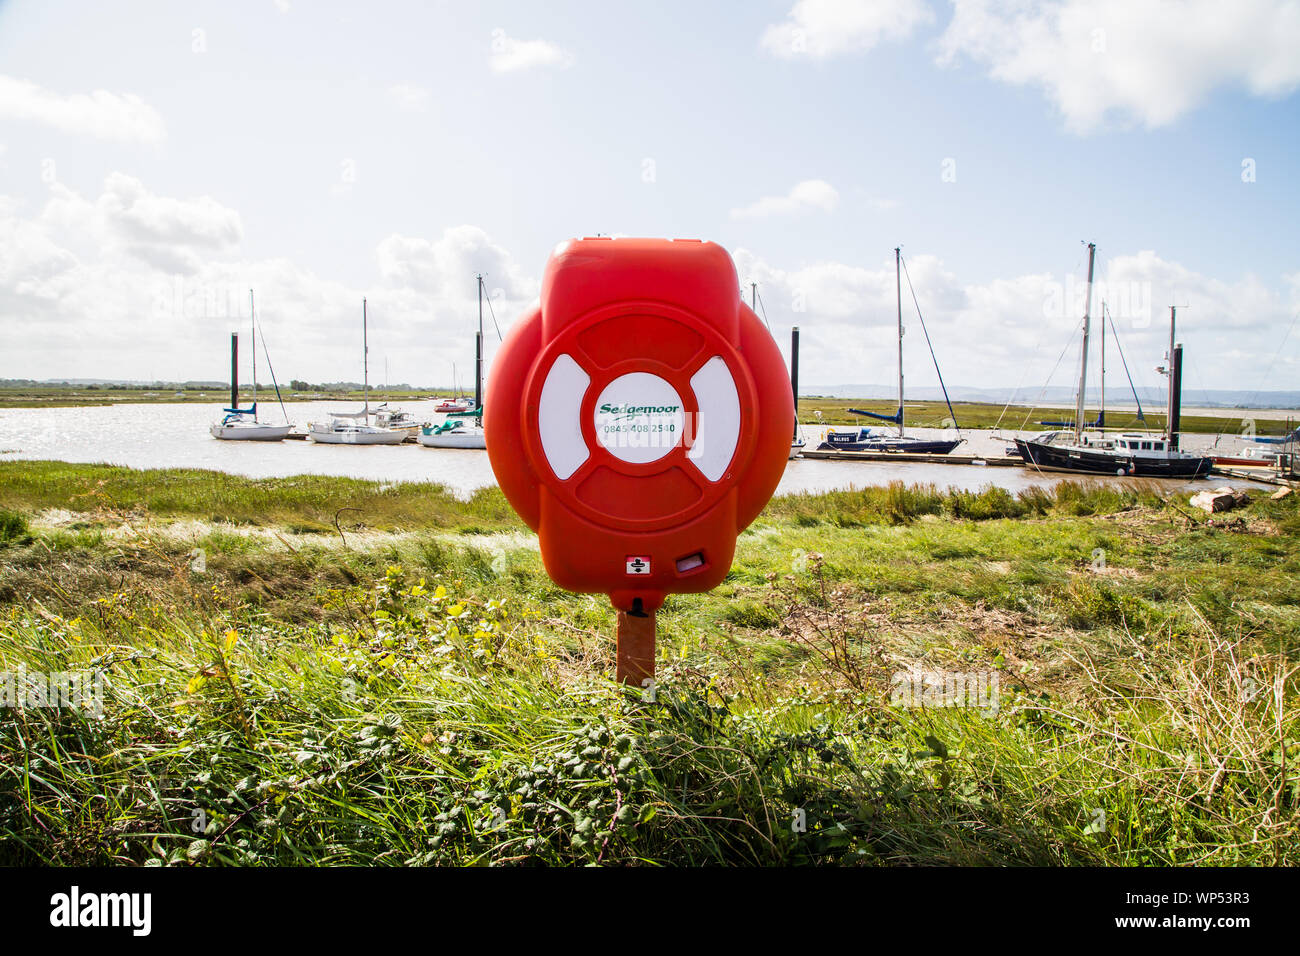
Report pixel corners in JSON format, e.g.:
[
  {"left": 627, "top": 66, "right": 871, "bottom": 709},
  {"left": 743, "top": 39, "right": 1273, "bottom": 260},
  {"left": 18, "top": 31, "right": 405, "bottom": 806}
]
[{"left": 0, "top": 0, "right": 1300, "bottom": 397}]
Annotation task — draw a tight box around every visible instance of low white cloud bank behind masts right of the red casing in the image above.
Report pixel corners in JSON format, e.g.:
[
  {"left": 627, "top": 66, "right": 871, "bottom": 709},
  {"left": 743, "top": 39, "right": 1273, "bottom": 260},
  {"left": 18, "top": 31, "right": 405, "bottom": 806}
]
[{"left": 735, "top": 248, "right": 1300, "bottom": 399}]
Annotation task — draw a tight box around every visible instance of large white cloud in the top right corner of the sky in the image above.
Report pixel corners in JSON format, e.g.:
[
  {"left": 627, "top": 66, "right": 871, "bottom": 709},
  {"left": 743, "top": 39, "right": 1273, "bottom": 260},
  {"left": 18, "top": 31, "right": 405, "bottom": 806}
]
[{"left": 939, "top": 0, "right": 1300, "bottom": 133}]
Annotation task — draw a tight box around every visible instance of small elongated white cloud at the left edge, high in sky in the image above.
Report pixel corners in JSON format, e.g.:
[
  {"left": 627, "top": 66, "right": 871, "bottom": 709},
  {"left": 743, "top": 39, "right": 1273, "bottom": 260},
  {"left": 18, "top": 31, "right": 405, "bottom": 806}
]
[{"left": 0, "top": 75, "right": 166, "bottom": 143}]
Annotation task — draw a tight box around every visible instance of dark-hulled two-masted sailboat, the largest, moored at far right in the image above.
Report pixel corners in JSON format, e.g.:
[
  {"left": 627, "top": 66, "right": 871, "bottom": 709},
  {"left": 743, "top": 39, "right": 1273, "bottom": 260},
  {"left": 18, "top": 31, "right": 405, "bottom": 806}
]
[{"left": 1015, "top": 242, "right": 1214, "bottom": 479}]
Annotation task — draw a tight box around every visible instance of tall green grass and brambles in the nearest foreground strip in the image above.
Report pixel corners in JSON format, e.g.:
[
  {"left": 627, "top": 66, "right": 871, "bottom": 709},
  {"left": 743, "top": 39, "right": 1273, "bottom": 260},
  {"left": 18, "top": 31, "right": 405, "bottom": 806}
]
[{"left": 0, "top": 568, "right": 1300, "bottom": 865}]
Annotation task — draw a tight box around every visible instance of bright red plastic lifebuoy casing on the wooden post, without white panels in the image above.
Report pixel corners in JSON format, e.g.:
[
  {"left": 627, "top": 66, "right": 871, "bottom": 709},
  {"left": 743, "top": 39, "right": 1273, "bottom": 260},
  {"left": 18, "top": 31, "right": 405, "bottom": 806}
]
[{"left": 484, "top": 238, "right": 794, "bottom": 611}]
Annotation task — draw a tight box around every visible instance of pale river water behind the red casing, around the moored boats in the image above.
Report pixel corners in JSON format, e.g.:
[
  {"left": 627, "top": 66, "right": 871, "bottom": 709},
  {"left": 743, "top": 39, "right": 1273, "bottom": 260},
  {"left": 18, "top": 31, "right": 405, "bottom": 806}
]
[{"left": 0, "top": 402, "right": 1262, "bottom": 497}]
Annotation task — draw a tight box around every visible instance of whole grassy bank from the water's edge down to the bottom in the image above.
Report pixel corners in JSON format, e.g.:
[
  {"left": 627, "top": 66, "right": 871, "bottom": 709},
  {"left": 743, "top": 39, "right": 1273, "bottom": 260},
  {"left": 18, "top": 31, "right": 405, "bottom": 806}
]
[{"left": 0, "top": 462, "right": 1300, "bottom": 865}]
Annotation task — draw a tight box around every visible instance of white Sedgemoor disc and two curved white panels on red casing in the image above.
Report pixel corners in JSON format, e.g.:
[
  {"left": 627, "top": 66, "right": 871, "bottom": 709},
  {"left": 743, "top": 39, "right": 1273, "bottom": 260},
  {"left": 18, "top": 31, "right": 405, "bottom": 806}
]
[{"left": 538, "top": 354, "right": 740, "bottom": 481}]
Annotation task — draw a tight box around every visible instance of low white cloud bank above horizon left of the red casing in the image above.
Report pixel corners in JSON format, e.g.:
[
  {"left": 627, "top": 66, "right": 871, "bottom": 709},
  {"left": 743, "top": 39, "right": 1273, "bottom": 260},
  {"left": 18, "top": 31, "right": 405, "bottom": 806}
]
[{"left": 0, "top": 173, "right": 540, "bottom": 384}]
